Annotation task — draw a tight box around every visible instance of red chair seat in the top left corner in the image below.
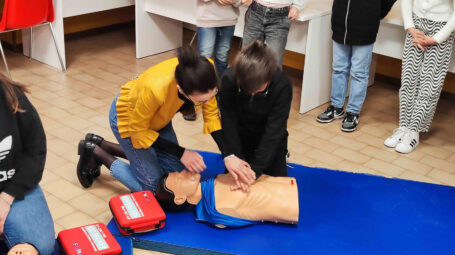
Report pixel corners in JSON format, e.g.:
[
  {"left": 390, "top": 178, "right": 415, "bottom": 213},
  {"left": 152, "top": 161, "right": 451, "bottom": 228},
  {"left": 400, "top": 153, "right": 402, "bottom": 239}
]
[{"left": 0, "top": 0, "right": 54, "bottom": 31}]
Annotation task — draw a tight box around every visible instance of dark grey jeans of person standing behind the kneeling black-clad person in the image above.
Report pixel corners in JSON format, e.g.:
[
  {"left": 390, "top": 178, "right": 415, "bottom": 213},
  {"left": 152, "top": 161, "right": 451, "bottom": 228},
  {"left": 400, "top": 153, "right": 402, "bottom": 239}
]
[{"left": 242, "top": 1, "right": 291, "bottom": 67}]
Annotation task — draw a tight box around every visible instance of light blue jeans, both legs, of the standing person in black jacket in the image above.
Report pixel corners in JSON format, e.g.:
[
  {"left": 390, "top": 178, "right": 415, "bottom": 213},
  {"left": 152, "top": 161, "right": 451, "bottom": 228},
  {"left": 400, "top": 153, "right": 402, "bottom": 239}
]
[{"left": 330, "top": 41, "right": 374, "bottom": 114}]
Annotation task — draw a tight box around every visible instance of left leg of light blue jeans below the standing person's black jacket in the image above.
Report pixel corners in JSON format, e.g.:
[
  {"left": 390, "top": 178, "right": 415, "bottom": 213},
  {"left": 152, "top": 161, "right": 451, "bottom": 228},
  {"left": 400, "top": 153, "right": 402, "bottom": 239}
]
[{"left": 330, "top": 41, "right": 352, "bottom": 108}]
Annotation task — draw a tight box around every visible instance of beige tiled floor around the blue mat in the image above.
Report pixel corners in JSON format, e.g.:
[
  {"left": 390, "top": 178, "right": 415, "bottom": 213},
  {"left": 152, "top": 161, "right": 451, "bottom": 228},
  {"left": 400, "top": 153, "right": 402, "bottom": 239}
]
[{"left": 7, "top": 25, "right": 455, "bottom": 254}]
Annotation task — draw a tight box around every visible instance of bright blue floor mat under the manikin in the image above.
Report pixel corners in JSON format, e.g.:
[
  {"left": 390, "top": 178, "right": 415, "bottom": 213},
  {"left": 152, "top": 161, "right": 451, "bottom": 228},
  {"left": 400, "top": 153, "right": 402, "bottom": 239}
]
[{"left": 108, "top": 153, "right": 455, "bottom": 255}]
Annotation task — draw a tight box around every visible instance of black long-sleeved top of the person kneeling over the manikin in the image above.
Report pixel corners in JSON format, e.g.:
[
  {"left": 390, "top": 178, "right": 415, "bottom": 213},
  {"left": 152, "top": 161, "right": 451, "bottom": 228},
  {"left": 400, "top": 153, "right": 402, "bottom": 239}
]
[{"left": 219, "top": 68, "right": 292, "bottom": 177}]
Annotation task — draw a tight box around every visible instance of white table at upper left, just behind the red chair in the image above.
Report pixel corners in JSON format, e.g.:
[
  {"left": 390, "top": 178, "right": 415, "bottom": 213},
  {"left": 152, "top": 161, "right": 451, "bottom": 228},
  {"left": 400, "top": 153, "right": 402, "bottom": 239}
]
[{"left": 22, "top": 0, "right": 134, "bottom": 69}]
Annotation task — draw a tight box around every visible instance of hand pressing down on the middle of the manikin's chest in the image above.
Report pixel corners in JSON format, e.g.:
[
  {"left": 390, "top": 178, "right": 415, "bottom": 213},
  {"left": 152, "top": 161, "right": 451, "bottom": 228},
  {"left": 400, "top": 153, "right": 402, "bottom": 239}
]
[{"left": 224, "top": 156, "right": 256, "bottom": 190}]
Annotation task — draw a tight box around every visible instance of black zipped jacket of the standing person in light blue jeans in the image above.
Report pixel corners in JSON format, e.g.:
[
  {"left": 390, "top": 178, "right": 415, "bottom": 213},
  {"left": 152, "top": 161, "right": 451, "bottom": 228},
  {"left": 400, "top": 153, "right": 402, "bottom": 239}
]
[{"left": 332, "top": 0, "right": 396, "bottom": 45}]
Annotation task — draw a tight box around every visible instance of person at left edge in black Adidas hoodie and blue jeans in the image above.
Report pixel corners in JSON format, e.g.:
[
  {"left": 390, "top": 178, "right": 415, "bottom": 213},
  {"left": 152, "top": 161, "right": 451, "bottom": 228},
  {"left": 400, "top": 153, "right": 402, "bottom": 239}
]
[{"left": 0, "top": 75, "right": 55, "bottom": 255}]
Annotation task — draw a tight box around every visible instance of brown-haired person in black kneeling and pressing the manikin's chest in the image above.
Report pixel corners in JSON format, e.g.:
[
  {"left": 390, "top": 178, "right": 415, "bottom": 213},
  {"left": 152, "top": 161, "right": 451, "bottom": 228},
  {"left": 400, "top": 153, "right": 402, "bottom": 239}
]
[{"left": 219, "top": 41, "right": 292, "bottom": 190}]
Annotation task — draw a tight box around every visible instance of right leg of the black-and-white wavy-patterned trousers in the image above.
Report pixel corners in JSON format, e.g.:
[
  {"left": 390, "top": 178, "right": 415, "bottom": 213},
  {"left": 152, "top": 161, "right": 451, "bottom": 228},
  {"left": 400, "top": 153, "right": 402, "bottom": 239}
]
[{"left": 408, "top": 32, "right": 454, "bottom": 133}]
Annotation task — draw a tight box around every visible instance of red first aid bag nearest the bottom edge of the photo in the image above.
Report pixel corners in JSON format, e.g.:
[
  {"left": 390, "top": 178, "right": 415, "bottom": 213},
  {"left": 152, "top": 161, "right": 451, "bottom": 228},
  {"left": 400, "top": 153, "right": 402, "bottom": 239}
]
[{"left": 57, "top": 223, "right": 122, "bottom": 255}]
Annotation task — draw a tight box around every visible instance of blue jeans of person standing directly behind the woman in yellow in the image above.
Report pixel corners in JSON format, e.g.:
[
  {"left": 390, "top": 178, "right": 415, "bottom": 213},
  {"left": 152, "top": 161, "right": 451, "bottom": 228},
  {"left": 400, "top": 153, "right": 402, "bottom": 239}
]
[{"left": 197, "top": 26, "right": 235, "bottom": 77}]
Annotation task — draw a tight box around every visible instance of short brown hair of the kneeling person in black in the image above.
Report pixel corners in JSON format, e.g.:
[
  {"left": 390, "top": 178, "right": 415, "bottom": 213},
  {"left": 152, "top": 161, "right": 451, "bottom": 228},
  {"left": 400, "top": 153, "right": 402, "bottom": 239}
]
[{"left": 234, "top": 40, "right": 278, "bottom": 94}]
